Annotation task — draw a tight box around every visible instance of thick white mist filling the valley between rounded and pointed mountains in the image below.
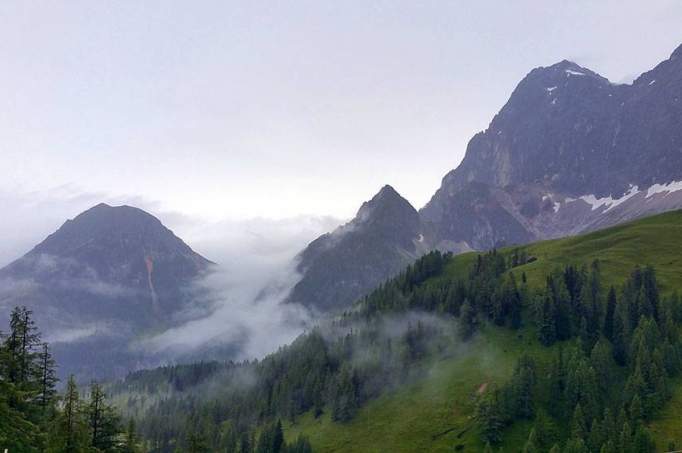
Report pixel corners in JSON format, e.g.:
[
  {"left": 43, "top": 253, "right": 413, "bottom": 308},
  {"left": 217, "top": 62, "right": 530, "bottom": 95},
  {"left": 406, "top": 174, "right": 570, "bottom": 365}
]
[{"left": 139, "top": 217, "right": 338, "bottom": 359}]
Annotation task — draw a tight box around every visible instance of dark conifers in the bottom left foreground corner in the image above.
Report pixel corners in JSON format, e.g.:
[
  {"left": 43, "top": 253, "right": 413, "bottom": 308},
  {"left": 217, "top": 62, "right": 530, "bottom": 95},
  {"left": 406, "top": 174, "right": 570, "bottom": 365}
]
[{"left": 0, "top": 307, "right": 142, "bottom": 453}]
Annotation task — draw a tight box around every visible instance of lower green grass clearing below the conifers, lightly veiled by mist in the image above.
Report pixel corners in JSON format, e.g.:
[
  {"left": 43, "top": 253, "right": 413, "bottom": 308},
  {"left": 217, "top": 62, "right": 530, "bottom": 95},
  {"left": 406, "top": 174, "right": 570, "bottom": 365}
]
[{"left": 285, "top": 328, "right": 539, "bottom": 452}]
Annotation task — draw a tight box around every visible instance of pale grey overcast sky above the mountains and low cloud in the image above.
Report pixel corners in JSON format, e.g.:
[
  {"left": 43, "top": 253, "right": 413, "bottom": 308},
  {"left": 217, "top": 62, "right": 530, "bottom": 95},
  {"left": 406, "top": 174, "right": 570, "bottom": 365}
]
[{"left": 0, "top": 0, "right": 682, "bottom": 254}]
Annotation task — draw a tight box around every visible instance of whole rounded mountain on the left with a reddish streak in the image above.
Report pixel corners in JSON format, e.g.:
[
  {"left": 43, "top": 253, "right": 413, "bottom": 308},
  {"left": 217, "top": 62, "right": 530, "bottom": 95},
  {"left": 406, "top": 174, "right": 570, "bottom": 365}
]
[{"left": 0, "top": 204, "right": 212, "bottom": 375}]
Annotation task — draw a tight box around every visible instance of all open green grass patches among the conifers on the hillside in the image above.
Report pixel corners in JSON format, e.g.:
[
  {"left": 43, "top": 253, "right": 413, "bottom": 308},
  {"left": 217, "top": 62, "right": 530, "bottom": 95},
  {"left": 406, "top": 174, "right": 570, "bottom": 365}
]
[{"left": 285, "top": 211, "right": 682, "bottom": 452}]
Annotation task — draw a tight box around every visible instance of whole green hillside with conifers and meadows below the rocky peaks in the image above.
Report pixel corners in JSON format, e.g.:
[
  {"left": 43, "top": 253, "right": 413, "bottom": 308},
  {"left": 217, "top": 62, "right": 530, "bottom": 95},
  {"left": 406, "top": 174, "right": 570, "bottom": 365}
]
[{"left": 103, "top": 212, "right": 682, "bottom": 452}]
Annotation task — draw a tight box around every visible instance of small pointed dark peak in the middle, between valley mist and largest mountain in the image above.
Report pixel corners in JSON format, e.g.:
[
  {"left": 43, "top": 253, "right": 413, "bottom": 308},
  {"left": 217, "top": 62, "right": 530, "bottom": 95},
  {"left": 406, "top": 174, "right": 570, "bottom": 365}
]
[{"left": 289, "top": 185, "right": 425, "bottom": 311}]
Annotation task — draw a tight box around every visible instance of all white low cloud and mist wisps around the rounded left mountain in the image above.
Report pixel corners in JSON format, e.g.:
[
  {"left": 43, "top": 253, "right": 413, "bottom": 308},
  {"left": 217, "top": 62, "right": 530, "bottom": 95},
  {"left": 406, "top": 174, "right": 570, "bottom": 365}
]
[{"left": 0, "top": 186, "right": 342, "bottom": 359}]
